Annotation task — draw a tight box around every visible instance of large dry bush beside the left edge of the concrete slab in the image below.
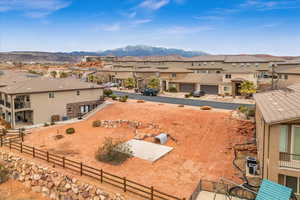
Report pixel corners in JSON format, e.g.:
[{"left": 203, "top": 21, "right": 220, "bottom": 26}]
[{"left": 96, "top": 137, "right": 132, "bottom": 165}]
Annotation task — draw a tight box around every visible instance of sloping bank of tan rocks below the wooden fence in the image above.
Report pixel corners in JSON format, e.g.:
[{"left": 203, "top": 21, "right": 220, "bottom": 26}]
[{"left": 0, "top": 150, "right": 125, "bottom": 200}]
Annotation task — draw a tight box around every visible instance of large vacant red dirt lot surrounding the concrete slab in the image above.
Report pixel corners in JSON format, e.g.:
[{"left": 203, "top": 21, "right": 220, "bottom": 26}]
[{"left": 25, "top": 101, "right": 252, "bottom": 197}]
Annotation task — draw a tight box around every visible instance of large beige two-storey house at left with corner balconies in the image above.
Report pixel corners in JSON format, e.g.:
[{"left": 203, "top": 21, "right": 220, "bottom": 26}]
[{"left": 0, "top": 77, "right": 103, "bottom": 128}]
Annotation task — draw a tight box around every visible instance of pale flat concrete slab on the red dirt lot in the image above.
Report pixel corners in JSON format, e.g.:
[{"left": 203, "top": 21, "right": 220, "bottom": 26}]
[{"left": 126, "top": 139, "right": 173, "bottom": 162}]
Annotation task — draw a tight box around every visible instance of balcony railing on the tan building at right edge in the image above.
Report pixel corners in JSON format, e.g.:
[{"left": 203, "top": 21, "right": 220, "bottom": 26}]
[{"left": 279, "top": 152, "right": 300, "bottom": 170}]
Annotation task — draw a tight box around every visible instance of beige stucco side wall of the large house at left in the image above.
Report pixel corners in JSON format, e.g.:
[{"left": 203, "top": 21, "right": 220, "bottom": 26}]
[{"left": 23, "top": 89, "right": 103, "bottom": 124}]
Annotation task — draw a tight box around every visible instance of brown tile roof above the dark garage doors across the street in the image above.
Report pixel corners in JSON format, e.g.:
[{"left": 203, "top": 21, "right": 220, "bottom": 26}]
[{"left": 170, "top": 74, "right": 223, "bottom": 85}]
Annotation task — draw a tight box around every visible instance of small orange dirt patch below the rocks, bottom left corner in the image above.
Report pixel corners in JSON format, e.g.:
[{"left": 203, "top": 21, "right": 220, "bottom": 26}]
[{"left": 0, "top": 180, "right": 47, "bottom": 200}]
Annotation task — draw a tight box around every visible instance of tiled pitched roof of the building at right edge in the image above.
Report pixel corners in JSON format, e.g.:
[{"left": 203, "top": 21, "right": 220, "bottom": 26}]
[{"left": 254, "top": 84, "right": 300, "bottom": 124}]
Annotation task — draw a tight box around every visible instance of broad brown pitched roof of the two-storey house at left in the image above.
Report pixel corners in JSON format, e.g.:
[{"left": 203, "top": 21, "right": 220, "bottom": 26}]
[{"left": 0, "top": 77, "right": 102, "bottom": 94}]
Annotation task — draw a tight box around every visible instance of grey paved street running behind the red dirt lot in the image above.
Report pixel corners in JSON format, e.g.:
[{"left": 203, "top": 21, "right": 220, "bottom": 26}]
[{"left": 114, "top": 91, "right": 254, "bottom": 110}]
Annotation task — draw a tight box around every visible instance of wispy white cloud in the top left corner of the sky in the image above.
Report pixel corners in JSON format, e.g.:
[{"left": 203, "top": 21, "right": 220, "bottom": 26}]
[{"left": 0, "top": 0, "right": 71, "bottom": 18}]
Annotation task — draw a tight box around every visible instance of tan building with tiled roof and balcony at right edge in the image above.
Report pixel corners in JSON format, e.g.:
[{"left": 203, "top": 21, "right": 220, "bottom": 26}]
[{"left": 254, "top": 84, "right": 300, "bottom": 195}]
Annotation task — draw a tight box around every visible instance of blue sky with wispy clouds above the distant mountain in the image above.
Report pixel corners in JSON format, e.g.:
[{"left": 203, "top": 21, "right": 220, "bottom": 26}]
[{"left": 0, "top": 0, "right": 300, "bottom": 55}]
